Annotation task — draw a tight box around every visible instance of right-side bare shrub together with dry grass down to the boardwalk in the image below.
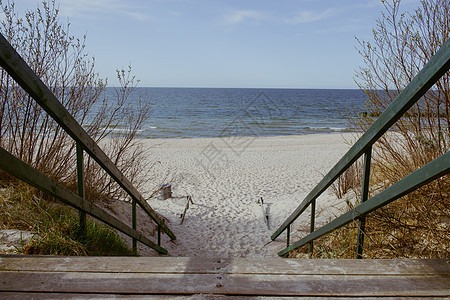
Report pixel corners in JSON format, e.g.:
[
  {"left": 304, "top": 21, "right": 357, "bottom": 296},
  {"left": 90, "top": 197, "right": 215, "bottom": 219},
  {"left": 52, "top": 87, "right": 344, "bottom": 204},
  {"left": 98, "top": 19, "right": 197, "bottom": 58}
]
[{"left": 291, "top": 0, "right": 450, "bottom": 258}]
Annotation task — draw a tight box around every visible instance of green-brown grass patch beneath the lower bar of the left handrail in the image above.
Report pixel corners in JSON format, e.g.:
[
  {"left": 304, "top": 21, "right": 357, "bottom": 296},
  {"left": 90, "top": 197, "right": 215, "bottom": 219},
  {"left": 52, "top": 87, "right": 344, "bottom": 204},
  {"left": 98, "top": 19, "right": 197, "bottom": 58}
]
[{"left": 0, "top": 173, "right": 135, "bottom": 255}]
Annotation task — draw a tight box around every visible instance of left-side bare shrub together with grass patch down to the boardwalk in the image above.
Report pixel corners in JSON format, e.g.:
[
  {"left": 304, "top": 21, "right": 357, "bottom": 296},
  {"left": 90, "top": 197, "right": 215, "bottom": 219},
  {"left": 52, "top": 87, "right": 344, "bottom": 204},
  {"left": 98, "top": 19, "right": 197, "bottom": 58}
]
[{"left": 0, "top": 1, "right": 150, "bottom": 255}]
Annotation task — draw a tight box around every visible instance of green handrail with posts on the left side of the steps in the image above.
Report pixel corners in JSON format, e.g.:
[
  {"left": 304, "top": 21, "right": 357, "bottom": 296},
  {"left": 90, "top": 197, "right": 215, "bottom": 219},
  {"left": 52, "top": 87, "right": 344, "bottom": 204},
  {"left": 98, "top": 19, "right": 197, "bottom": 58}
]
[{"left": 0, "top": 34, "right": 176, "bottom": 253}]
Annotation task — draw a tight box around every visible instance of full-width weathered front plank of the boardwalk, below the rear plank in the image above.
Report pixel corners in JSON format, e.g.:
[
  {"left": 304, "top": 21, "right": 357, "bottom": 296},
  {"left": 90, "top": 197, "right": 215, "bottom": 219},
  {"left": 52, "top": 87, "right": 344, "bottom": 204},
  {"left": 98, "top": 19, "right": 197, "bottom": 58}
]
[{"left": 0, "top": 271, "right": 450, "bottom": 297}]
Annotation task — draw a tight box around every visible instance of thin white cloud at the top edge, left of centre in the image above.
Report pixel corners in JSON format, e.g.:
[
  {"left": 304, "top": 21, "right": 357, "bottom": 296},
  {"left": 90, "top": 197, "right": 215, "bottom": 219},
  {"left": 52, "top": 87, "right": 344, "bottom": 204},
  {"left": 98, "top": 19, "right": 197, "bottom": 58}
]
[{"left": 60, "top": 0, "right": 148, "bottom": 21}]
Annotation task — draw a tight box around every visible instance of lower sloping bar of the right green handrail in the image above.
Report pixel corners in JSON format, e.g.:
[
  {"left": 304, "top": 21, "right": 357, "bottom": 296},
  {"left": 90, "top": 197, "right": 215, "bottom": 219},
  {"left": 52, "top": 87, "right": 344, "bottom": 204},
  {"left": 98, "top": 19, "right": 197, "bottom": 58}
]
[{"left": 278, "top": 151, "right": 450, "bottom": 256}]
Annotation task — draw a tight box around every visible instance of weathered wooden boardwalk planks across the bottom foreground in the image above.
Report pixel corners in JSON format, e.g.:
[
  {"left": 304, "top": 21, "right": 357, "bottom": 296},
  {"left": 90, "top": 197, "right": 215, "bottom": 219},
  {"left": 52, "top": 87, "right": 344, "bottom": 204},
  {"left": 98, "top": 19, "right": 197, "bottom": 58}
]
[{"left": 0, "top": 256, "right": 450, "bottom": 299}]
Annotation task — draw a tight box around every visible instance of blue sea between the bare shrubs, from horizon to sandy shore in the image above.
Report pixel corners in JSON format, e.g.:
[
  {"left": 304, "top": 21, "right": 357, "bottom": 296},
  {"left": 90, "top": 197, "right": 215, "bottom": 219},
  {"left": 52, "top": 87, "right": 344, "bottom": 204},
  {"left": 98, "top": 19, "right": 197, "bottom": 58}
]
[{"left": 107, "top": 88, "right": 364, "bottom": 138}]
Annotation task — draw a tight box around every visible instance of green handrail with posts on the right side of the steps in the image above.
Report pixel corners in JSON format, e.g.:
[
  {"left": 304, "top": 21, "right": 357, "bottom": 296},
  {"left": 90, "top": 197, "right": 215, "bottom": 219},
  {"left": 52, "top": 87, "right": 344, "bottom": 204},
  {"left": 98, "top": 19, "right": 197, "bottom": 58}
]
[{"left": 271, "top": 40, "right": 450, "bottom": 258}]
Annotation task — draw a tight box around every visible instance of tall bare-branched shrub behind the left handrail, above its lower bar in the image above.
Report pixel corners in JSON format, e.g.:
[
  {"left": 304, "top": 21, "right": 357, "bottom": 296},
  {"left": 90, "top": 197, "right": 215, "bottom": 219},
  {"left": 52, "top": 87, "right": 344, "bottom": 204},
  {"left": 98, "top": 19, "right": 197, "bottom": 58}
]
[{"left": 0, "top": 1, "right": 150, "bottom": 201}]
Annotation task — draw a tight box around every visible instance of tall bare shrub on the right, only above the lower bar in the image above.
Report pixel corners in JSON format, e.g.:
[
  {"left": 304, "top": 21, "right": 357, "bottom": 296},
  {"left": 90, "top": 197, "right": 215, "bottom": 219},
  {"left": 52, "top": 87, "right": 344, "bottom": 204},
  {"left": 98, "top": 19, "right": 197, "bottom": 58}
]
[{"left": 353, "top": 0, "right": 450, "bottom": 166}]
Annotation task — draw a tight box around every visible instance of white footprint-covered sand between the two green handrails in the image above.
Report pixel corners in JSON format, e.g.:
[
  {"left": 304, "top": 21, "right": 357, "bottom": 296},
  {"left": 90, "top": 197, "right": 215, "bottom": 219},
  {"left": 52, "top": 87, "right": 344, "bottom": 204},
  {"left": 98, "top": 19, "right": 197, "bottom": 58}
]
[{"left": 118, "top": 133, "right": 353, "bottom": 257}]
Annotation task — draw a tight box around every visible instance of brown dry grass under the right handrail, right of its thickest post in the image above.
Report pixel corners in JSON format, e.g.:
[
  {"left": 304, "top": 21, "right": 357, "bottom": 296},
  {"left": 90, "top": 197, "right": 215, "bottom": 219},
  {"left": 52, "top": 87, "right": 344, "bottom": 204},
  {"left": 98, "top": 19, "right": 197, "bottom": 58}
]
[{"left": 366, "top": 175, "right": 450, "bottom": 258}]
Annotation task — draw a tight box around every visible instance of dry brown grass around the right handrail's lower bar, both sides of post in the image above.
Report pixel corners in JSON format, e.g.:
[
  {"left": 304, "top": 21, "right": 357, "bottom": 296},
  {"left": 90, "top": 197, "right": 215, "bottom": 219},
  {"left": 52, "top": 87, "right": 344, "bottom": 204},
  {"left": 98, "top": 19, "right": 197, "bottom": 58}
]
[{"left": 290, "top": 142, "right": 450, "bottom": 258}]
